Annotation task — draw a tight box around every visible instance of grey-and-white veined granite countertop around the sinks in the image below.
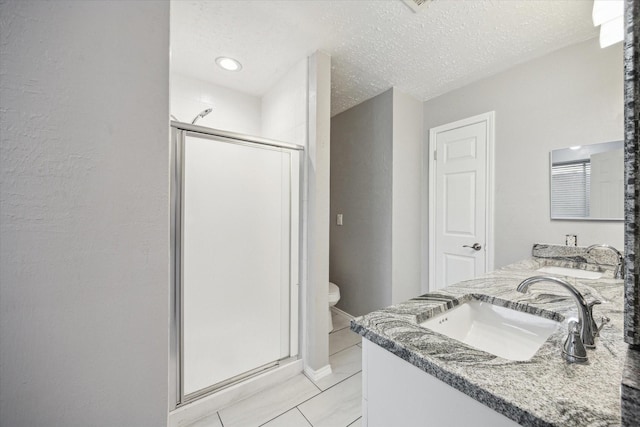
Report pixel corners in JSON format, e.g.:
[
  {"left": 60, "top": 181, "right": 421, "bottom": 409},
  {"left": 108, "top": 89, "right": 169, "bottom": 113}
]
[{"left": 351, "top": 251, "right": 627, "bottom": 427}]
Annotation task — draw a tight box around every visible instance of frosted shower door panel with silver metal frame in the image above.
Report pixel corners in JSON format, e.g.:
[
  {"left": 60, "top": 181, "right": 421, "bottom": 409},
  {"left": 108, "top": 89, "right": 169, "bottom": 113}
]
[{"left": 171, "top": 122, "right": 303, "bottom": 409}]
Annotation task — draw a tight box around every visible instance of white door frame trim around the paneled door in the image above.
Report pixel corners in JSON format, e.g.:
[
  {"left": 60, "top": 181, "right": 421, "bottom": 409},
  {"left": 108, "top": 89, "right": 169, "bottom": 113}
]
[{"left": 423, "top": 111, "right": 496, "bottom": 292}]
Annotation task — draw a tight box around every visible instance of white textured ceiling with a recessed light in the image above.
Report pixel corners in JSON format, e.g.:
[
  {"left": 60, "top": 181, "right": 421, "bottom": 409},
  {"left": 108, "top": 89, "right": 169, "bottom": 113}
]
[{"left": 171, "top": 0, "right": 597, "bottom": 115}]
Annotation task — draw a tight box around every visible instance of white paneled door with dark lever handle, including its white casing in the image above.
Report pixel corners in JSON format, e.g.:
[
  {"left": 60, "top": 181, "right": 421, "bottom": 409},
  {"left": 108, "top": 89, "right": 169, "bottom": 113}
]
[{"left": 429, "top": 113, "right": 493, "bottom": 291}]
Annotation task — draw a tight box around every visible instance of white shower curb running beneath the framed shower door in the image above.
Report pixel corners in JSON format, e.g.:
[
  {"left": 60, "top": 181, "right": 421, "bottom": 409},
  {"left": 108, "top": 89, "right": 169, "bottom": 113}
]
[{"left": 168, "top": 359, "right": 302, "bottom": 427}]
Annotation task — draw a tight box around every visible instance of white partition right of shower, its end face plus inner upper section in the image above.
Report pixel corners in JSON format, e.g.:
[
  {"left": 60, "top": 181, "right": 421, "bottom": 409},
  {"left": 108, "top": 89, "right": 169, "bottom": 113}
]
[{"left": 260, "top": 52, "right": 331, "bottom": 378}]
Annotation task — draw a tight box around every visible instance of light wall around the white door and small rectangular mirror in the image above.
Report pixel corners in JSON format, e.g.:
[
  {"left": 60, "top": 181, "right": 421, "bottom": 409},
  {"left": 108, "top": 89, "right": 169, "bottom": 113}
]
[{"left": 424, "top": 39, "right": 623, "bottom": 267}]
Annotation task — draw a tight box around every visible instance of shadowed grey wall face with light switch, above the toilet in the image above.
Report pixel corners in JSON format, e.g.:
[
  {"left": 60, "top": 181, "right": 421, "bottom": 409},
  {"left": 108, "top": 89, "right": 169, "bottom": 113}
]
[{"left": 330, "top": 89, "right": 393, "bottom": 316}]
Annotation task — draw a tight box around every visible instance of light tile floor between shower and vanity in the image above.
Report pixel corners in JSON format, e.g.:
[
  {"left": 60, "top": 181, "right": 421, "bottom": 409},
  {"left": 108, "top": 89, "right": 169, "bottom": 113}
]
[{"left": 189, "top": 312, "right": 362, "bottom": 427}]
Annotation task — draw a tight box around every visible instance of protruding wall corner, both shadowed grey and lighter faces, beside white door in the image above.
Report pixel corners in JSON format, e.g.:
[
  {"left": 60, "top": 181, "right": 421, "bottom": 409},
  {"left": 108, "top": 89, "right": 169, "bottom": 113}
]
[{"left": 330, "top": 88, "right": 422, "bottom": 316}]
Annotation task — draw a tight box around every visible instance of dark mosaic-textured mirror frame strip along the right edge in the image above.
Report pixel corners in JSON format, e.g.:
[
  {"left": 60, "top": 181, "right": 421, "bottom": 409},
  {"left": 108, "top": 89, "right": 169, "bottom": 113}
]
[{"left": 624, "top": 0, "right": 640, "bottom": 346}]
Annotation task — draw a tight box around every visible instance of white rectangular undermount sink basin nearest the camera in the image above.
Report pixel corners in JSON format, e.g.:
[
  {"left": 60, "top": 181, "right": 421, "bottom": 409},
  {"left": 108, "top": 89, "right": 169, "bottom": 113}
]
[{"left": 420, "top": 300, "right": 560, "bottom": 361}]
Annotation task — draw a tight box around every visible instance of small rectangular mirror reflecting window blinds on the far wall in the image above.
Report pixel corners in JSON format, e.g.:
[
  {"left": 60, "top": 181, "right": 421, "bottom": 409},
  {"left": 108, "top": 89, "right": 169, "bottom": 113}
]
[{"left": 551, "top": 141, "right": 624, "bottom": 221}]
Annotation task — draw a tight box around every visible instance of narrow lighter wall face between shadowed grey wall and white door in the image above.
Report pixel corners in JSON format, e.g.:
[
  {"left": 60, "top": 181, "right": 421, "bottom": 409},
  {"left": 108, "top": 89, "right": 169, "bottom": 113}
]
[{"left": 391, "top": 89, "right": 423, "bottom": 304}]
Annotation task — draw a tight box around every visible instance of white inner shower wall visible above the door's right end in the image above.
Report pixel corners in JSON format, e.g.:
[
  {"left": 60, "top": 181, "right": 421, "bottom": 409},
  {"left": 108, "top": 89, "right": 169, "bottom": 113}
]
[{"left": 260, "top": 58, "right": 308, "bottom": 145}]
